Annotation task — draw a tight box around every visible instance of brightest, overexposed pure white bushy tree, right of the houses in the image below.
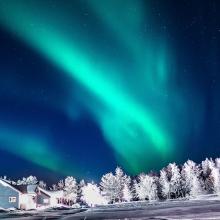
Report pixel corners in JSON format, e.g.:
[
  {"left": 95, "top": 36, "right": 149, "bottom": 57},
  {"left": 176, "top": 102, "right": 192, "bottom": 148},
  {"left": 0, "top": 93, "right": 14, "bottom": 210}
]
[{"left": 81, "top": 183, "right": 107, "bottom": 207}]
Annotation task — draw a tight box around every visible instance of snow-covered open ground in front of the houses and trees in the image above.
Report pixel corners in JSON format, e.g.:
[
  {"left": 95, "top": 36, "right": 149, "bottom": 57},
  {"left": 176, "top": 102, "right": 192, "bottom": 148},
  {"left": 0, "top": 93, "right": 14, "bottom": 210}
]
[{"left": 0, "top": 196, "right": 220, "bottom": 220}]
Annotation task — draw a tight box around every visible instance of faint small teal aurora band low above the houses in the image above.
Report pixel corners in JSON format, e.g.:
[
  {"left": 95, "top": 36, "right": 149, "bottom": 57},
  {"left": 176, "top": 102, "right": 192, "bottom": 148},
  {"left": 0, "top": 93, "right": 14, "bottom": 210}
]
[{"left": 0, "top": 128, "right": 73, "bottom": 175}]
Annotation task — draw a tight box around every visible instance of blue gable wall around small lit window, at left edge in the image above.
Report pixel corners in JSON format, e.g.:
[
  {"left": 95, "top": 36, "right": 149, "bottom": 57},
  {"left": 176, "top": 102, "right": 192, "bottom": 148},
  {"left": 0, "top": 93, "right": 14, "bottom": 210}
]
[{"left": 0, "top": 182, "right": 19, "bottom": 209}]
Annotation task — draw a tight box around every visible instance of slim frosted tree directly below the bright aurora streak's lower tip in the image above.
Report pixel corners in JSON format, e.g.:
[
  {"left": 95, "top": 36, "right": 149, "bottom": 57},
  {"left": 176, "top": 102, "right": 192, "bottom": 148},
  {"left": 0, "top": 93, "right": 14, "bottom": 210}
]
[{"left": 159, "top": 169, "right": 170, "bottom": 199}]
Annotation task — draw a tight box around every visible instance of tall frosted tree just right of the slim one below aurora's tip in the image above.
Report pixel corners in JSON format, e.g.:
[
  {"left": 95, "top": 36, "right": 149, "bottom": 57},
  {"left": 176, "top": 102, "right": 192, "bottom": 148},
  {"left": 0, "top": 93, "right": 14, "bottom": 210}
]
[{"left": 167, "top": 163, "right": 181, "bottom": 198}]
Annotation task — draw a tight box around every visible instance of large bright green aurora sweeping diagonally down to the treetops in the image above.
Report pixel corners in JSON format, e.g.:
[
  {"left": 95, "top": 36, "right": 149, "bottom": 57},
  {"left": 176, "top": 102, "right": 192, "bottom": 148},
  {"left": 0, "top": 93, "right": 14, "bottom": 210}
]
[{"left": 0, "top": 0, "right": 198, "bottom": 173}]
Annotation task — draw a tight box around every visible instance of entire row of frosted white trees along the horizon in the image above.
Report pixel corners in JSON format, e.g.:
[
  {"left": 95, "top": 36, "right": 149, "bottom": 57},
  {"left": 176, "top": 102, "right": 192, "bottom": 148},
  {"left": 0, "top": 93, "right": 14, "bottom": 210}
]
[{"left": 2, "top": 158, "right": 220, "bottom": 206}]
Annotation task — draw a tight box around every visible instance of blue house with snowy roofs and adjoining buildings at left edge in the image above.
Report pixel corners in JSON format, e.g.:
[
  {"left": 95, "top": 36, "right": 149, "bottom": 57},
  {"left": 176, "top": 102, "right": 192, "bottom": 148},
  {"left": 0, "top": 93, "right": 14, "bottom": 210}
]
[{"left": 0, "top": 179, "right": 63, "bottom": 210}]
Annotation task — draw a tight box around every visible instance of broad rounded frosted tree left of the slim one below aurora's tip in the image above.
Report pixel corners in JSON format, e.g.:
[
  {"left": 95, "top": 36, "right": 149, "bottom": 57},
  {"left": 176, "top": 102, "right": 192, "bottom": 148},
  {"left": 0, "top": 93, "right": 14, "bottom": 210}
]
[{"left": 134, "top": 174, "right": 158, "bottom": 201}]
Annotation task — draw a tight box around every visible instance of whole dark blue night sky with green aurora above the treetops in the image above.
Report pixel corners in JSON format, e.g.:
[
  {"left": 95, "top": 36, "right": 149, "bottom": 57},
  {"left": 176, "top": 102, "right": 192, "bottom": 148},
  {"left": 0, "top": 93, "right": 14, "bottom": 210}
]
[{"left": 0, "top": 0, "right": 220, "bottom": 181}]
